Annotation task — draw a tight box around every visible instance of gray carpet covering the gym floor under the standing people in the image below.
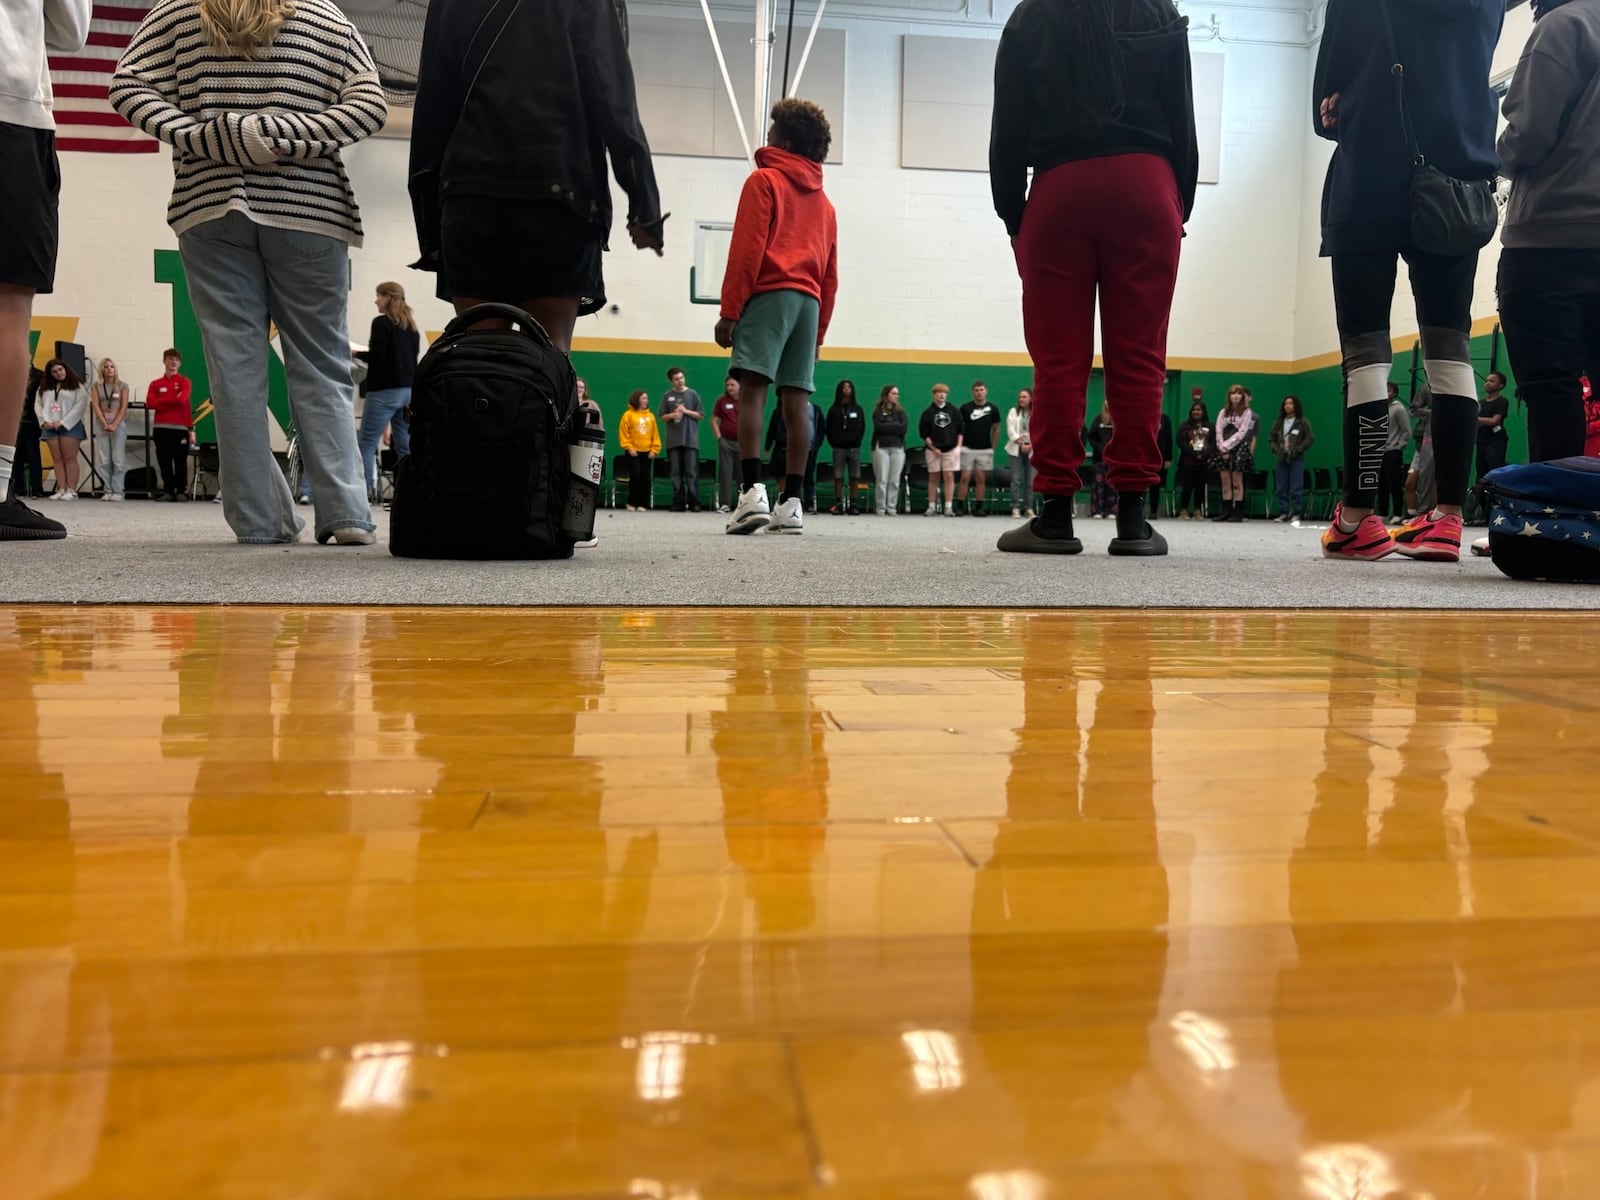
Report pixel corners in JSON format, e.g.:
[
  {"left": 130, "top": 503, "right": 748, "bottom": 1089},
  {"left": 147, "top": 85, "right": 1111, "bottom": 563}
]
[{"left": 0, "top": 501, "right": 1600, "bottom": 610}]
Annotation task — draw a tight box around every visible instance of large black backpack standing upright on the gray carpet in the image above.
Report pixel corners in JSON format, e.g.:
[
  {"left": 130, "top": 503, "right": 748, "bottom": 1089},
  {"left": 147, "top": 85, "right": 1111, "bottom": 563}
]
[{"left": 389, "top": 304, "right": 578, "bottom": 558}]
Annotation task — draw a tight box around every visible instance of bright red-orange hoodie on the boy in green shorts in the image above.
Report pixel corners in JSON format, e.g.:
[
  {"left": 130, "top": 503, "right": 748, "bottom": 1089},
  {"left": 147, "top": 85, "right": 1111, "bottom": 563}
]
[{"left": 722, "top": 146, "right": 838, "bottom": 346}]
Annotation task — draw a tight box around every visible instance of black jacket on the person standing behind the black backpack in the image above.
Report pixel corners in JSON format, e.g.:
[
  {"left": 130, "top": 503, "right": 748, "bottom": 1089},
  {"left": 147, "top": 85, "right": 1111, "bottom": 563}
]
[{"left": 410, "top": 0, "right": 661, "bottom": 270}]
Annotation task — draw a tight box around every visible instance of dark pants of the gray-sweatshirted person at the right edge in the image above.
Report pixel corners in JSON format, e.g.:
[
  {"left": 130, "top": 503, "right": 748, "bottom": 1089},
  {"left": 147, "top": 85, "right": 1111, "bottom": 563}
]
[{"left": 1497, "top": 250, "right": 1600, "bottom": 464}]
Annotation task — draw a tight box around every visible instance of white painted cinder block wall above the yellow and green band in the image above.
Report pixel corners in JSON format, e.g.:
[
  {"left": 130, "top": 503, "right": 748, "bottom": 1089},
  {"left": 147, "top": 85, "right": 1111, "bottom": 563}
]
[{"left": 50, "top": 5, "right": 1333, "bottom": 378}]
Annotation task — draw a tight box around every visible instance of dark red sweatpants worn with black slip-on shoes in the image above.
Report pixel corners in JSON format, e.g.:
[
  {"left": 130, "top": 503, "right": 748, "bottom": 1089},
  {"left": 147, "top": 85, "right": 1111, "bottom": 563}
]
[{"left": 1016, "top": 154, "right": 1184, "bottom": 496}]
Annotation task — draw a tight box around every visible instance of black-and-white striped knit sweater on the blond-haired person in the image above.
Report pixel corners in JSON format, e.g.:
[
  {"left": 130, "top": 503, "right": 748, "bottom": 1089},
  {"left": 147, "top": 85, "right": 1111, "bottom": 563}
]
[{"left": 110, "top": 0, "right": 389, "bottom": 246}]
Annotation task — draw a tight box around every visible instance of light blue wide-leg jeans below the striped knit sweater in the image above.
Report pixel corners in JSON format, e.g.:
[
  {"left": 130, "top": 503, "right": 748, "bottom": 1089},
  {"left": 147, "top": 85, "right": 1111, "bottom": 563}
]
[{"left": 178, "top": 213, "right": 373, "bottom": 544}]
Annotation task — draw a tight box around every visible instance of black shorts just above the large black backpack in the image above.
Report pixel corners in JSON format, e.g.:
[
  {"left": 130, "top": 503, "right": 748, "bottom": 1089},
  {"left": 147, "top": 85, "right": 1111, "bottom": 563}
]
[{"left": 438, "top": 195, "right": 605, "bottom": 315}]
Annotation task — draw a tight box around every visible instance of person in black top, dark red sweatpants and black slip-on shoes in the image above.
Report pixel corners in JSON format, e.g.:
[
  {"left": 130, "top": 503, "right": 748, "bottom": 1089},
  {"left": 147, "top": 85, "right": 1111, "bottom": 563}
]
[{"left": 989, "top": 0, "right": 1200, "bottom": 555}]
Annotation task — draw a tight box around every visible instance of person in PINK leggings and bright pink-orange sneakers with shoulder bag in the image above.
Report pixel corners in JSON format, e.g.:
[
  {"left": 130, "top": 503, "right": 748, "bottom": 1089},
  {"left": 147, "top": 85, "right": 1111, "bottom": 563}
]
[{"left": 1312, "top": 0, "right": 1506, "bottom": 562}]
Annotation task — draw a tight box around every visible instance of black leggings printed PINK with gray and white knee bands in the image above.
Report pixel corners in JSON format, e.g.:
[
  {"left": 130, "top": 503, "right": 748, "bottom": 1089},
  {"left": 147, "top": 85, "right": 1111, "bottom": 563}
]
[{"left": 1333, "top": 248, "right": 1478, "bottom": 509}]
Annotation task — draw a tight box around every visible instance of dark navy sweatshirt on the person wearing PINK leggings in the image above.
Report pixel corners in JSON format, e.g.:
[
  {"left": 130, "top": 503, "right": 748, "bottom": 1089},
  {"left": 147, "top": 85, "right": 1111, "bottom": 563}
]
[{"left": 1310, "top": 0, "right": 1506, "bottom": 256}]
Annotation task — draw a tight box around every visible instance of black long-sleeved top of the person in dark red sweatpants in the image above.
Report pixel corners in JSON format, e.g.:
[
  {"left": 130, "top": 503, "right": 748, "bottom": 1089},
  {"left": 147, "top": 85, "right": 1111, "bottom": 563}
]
[{"left": 989, "top": 0, "right": 1200, "bottom": 237}]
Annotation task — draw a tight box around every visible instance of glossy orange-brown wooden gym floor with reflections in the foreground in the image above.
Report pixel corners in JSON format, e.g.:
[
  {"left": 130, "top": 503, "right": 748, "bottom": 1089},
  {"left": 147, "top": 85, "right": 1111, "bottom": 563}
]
[{"left": 0, "top": 608, "right": 1600, "bottom": 1200}]
